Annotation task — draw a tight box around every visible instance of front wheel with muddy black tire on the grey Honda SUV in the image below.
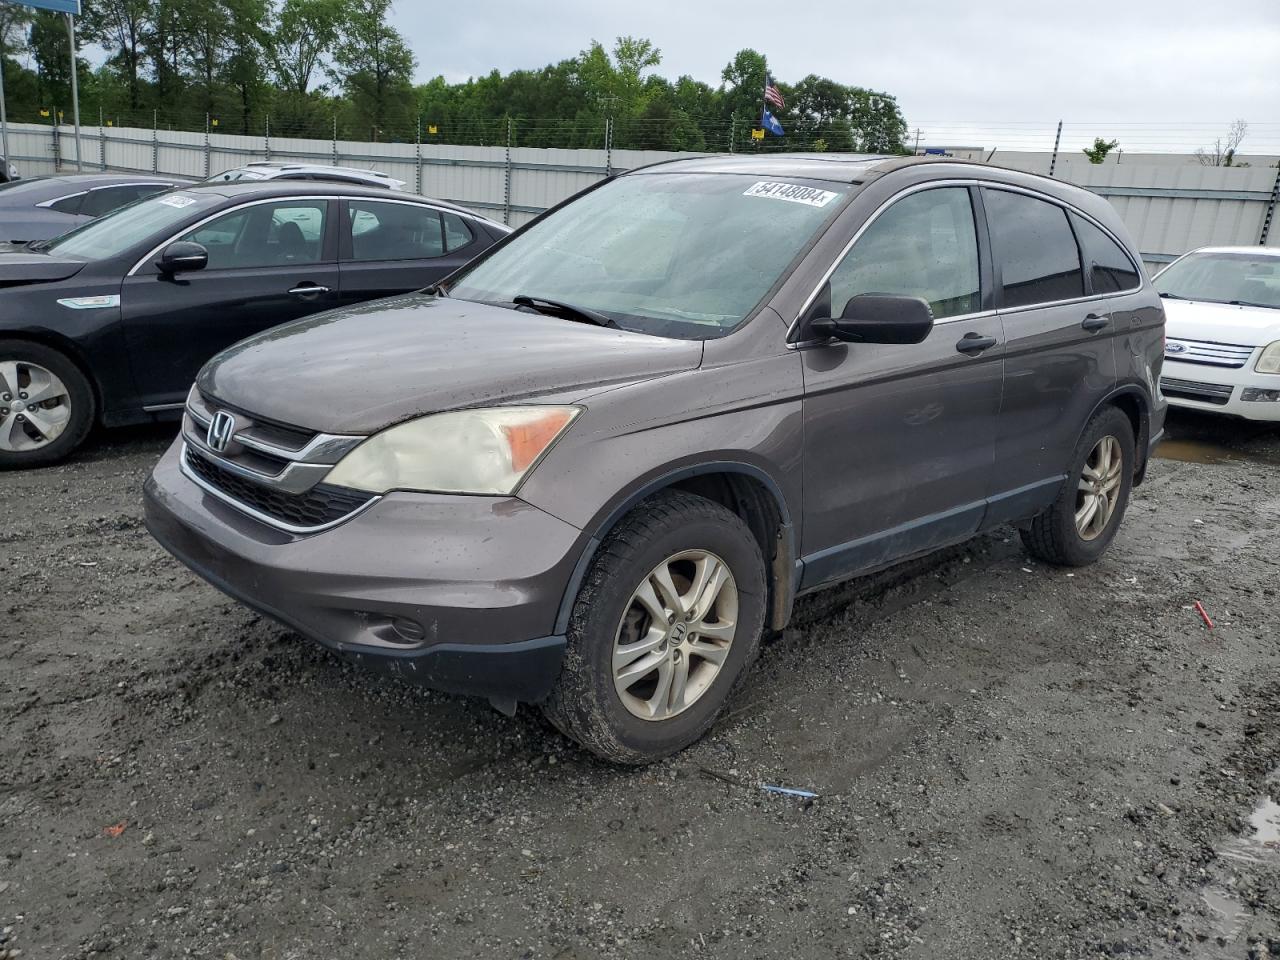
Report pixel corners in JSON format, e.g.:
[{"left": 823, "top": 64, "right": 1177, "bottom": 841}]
[{"left": 543, "top": 490, "right": 767, "bottom": 764}]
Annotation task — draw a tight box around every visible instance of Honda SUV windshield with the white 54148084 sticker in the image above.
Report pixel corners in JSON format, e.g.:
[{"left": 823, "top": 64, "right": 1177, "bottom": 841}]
[{"left": 449, "top": 173, "right": 849, "bottom": 339}]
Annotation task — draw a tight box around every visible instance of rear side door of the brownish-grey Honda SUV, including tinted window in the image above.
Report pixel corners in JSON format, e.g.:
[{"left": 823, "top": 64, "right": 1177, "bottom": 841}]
[{"left": 982, "top": 187, "right": 1128, "bottom": 526}]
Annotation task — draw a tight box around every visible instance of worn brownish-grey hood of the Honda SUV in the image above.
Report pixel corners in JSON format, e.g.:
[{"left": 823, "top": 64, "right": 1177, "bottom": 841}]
[{"left": 197, "top": 293, "right": 703, "bottom": 434}]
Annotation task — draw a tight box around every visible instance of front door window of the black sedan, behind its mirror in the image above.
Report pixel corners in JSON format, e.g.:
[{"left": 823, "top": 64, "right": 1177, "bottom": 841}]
[{"left": 179, "top": 200, "right": 329, "bottom": 270}]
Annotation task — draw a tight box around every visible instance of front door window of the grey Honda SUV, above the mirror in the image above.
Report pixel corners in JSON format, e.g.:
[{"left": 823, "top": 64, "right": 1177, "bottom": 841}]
[{"left": 831, "top": 187, "right": 982, "bottom": 320}]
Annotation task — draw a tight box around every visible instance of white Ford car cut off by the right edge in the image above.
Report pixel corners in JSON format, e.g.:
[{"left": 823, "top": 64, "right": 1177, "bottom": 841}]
[{"left": 1155, "top": 247, "right": 1280, "bottom": 421}]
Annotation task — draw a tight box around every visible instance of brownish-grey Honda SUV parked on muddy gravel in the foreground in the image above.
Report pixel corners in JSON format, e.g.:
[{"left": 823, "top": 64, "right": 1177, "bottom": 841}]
[{"left": 146, "top": 155, "right": 1165, "bottom": 762}]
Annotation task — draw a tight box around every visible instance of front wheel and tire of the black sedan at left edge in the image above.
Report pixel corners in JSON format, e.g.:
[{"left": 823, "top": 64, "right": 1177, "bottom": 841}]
[{"left": 0, "top": 339, "right": 97, "bottom": 470}]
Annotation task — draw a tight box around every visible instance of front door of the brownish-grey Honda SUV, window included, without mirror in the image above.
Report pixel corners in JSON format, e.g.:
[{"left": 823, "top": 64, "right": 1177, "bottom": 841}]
[{"left": 800, "top": 186, "right": 1004, "bottom": 589}]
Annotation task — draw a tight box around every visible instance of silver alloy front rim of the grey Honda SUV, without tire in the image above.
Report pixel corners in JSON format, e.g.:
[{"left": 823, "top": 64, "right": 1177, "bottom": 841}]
[{"left": 613, "top": 550, "right": 737, "bottom": 721}]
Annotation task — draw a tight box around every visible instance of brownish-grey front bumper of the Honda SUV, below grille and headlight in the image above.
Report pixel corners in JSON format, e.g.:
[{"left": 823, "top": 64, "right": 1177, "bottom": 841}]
[{"left": 145, "top": 442, "right": 582, "bottom": 703}]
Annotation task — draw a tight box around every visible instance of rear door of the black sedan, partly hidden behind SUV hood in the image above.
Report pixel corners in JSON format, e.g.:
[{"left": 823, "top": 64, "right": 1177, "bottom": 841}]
[{"left": 339, "top": 197, "right": 489, "bottom": 303}]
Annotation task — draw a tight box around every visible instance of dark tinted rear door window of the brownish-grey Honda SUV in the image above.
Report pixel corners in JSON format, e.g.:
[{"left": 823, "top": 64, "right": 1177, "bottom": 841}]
[{"left": 982, "top": 189, "right": 1084, "bottom": 307}]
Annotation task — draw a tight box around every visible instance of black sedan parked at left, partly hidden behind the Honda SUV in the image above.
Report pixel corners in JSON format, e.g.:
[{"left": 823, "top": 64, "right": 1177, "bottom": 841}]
[{"left": 0, "top": 180, "right": 509, "bottom": 467}]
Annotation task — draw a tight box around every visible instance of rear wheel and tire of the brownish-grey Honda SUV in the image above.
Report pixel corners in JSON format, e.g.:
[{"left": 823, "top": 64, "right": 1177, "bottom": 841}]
[{"left": 1021, "top": 407, "right": 1137, "bottom": 567}]
